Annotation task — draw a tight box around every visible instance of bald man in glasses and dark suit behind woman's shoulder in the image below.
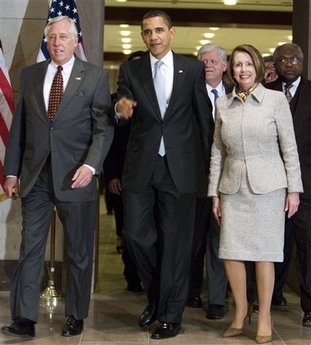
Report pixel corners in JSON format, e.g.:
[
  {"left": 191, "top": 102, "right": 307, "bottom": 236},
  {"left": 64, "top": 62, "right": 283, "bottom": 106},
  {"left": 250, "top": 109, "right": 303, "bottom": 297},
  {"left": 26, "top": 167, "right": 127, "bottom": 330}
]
[{"left": 267, "top": 43, "right": 311, "bottom": 327}]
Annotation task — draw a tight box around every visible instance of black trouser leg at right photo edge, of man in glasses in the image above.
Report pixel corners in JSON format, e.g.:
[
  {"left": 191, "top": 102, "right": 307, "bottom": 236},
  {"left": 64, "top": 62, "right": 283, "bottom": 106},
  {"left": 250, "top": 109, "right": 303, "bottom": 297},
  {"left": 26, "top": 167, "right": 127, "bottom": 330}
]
[{"left": 293, "top": 199, "right": 311, "bottom": 313}]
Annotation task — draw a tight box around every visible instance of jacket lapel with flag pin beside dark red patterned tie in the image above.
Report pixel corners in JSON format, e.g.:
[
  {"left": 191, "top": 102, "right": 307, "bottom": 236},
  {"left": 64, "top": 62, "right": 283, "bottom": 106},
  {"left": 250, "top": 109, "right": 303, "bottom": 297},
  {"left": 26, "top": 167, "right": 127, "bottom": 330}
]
[{"left": 55, "top": 57, "right": 85, "bottom": 120}]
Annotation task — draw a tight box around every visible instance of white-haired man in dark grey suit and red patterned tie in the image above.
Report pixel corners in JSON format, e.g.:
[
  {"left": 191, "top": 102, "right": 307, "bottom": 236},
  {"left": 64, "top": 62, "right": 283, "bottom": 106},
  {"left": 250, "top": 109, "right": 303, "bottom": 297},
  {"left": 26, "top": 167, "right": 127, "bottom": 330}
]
[{"left": 2, "top": 17, "right": 113, "bottom": 336}]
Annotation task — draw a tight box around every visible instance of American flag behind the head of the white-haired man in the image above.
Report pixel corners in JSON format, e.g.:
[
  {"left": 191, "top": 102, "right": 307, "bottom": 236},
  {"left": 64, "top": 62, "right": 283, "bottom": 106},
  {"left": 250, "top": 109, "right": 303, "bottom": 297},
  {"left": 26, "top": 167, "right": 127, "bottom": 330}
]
[{"left": 37, "top": 0, "right": 87, "bottom": 62}]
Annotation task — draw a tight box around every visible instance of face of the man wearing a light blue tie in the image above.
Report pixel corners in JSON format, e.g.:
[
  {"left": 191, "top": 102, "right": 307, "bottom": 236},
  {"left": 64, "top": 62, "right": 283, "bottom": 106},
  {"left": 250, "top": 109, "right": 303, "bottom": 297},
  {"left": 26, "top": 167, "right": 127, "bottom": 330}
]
[{"left": 141, "top": 16, "right": 175, "bottom": 59}]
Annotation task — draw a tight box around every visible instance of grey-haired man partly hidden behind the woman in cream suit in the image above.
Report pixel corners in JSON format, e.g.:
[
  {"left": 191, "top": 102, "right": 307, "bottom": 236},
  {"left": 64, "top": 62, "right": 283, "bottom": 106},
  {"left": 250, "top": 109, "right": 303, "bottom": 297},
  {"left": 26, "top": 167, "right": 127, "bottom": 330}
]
[{"left": 187, "top": 43, "right": 230, "bottom": 319}]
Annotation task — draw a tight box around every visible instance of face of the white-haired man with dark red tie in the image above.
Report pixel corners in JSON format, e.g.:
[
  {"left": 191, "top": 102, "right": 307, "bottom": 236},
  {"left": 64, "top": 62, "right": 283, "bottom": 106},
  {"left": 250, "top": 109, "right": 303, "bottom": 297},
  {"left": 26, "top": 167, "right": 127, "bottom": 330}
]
[{"left": 46, "top": 20, "right": 78, "bottom": 65}]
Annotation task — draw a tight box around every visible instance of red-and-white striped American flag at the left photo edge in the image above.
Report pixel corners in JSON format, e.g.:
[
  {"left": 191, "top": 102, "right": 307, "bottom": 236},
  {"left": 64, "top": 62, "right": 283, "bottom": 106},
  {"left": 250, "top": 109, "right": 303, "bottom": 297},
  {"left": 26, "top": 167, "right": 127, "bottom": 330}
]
[{"left": 0, "top": 40, "right": 14, "bottom": 200}]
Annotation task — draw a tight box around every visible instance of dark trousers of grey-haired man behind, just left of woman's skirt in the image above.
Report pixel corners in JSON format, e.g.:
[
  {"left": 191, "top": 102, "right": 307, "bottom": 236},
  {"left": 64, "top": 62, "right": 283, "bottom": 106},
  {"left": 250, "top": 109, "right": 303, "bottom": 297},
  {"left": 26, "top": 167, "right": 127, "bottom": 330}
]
[{"left": 189, "top": 198, "right": 228, "bottom": 305}]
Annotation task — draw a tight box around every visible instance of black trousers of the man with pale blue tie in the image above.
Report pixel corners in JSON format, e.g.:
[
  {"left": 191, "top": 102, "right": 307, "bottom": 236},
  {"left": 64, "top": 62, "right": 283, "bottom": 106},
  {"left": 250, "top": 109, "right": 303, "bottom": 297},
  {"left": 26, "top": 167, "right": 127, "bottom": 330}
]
[{"left": 123, "top": 156, "right": 195, "bottom": 323}]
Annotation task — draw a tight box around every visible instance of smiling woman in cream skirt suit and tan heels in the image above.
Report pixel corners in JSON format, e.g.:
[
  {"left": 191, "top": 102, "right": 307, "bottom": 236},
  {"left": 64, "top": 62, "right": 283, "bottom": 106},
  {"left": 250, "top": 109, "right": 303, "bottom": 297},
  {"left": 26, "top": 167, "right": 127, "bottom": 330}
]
[{"left": 208, "top": 45, "right": 302, "bottom": 344}]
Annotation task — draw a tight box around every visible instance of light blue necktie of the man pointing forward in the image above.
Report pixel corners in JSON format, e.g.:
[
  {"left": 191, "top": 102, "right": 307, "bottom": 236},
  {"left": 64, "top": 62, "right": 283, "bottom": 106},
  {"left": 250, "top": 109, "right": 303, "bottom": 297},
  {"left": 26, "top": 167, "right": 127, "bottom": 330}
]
[{"left": 153, "top": 60, "right": 166, "bottom": 157}]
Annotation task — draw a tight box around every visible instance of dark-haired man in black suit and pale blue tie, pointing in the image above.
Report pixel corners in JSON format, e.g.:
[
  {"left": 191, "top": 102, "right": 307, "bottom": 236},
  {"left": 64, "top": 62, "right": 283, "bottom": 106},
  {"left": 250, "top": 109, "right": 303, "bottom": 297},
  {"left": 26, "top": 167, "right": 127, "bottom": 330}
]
[{"left": 115, "top": 10, "right": 213, "bottom": 339}]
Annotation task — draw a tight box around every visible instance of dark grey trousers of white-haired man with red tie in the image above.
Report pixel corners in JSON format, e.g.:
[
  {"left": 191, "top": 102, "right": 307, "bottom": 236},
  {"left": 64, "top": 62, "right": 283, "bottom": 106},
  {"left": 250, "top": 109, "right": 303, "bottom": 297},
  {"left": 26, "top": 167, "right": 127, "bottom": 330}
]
[{"left": 11, "top": 163, "right": 98, "bottom": 322}]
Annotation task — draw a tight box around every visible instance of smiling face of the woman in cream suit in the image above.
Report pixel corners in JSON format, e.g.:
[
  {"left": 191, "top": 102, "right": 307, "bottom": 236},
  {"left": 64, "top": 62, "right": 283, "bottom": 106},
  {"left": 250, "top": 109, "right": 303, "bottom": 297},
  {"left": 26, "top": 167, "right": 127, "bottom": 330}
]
[{"left": 232, "top": 51, "right": 256, "bottom": 91}]
